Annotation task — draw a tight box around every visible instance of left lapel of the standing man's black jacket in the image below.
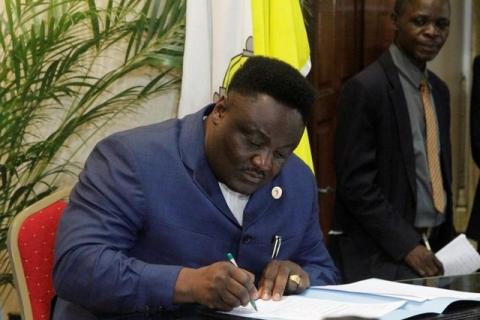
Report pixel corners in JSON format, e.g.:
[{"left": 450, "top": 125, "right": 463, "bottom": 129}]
[{"left": 380, "top": 51, "right": 416, "bottom": 201}]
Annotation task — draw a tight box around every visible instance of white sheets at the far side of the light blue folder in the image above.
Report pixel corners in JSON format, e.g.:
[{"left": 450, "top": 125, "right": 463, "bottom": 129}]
[{"left": 312, "top": 278, "right": 480, "bottom": 302}]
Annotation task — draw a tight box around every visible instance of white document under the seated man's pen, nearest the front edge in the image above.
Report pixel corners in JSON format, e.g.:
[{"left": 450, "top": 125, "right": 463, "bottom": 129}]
[{"left": 220, "top": 296, "right": 405, "bottom": 320}]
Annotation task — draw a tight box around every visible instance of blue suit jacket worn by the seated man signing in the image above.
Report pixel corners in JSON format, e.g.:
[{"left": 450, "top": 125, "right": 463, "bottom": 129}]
[{"left": 54, "top": 106, "right": 337, "bottom": 320}]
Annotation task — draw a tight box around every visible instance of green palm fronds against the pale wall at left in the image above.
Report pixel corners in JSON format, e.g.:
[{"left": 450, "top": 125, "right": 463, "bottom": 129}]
[{"left": 0, "top": 0, "right": 185, "bottom": 285}]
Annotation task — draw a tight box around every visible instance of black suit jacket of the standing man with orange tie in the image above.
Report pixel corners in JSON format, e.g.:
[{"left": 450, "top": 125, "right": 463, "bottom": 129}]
[{"left": 331, "top": 51, "right": 454, "bottom": 282}]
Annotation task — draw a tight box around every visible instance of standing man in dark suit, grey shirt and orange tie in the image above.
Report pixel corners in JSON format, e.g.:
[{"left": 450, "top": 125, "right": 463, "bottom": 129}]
[{"left": 330, "top": 0, "right": 454, "bottom": 282}]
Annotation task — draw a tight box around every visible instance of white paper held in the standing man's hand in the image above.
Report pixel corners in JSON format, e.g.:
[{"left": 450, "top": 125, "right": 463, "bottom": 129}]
[{"left": 435, "top": 234, "right": 480, "bottom": 276}]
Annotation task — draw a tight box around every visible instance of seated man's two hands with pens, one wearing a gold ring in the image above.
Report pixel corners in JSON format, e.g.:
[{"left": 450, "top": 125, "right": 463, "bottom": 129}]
[{"left": 174, "top": 231, "right": 310, "bottom": 311}]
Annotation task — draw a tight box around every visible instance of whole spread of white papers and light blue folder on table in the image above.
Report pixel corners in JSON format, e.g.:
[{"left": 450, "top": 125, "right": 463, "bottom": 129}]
[{"left": 222, "top": 278, "right": 480, "bottom": 320}]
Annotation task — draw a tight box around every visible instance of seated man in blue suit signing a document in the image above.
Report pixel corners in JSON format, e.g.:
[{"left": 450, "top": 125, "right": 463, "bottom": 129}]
[{"left": 54, "top": 57, "right": 337, "bottom": 320}]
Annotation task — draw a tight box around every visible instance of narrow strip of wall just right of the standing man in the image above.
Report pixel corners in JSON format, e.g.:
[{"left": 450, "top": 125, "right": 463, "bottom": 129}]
[{"left": 428, "top": 0, "right": 472, "bottom": 231}]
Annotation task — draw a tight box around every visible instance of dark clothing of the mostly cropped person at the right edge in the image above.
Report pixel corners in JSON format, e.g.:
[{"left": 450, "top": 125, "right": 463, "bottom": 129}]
[{"left": 467, "top": 56, "right": 480, "bottom": 245}]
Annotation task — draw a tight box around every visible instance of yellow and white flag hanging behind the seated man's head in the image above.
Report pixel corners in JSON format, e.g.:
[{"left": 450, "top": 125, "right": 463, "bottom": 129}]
[{"left": 178, "top": 0, "right": 313, "bottom": 171}]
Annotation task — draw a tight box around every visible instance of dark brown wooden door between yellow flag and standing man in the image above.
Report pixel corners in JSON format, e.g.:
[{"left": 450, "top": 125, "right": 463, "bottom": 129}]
[{"left": 308, "top": 0, "right": 394, "bottom": 241}]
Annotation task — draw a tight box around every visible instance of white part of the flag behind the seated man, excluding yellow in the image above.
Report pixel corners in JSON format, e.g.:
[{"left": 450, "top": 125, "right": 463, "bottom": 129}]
[{"left": 178, "top": 0, "right": 252, "bottom": 118}]
